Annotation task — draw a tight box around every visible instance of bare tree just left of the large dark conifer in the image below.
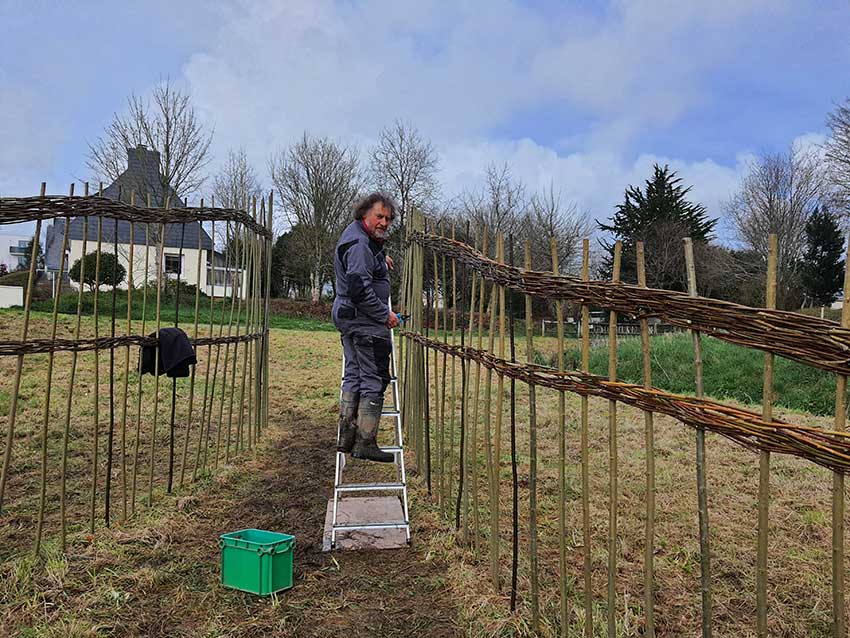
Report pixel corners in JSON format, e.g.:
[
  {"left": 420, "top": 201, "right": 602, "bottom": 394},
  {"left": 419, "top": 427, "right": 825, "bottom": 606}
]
[{"left": 523, "top": 183, "right": 593, "bottom": 273}]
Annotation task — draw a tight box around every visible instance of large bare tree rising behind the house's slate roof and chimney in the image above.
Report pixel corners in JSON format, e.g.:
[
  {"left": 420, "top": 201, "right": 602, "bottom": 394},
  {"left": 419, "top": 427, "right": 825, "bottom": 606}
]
[{"left": 87, "top": 80, "right": 213, "bottom": 206}]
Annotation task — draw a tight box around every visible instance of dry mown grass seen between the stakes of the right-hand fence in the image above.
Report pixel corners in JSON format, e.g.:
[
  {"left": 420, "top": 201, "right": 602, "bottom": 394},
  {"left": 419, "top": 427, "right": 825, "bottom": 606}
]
[{"left": 414, "top": 340, "right": 850, "bottom": 636}]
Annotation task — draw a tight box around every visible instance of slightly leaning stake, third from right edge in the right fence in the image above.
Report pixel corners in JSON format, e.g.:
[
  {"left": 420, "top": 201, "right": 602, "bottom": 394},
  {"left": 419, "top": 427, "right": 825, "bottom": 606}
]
[{"left": 684, "top": 237, "right": 712, "bottom": 638}]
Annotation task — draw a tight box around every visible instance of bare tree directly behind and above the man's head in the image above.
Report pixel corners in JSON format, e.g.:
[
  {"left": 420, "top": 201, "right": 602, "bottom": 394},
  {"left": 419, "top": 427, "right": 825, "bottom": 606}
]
[{"left": 369, "top": 120, "right": 439, "bottom": 229}]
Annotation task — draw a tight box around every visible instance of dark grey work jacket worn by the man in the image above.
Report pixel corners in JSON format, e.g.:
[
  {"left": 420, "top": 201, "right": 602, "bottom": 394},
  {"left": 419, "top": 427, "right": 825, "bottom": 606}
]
[{"left": 333, "top": 220, "right": 390, "bottom": 336}]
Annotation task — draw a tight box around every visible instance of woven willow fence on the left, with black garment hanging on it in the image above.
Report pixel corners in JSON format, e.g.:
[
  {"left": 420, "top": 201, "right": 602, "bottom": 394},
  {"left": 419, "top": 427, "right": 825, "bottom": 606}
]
[{"left": 0, "top": 184, "right": 273, "bottom": 552}]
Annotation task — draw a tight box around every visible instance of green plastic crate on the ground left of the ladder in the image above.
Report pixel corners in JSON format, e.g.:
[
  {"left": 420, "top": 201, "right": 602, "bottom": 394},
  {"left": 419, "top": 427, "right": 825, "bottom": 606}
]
[{"left": 218, "top": 529, "right": 295, "bottom": 596}]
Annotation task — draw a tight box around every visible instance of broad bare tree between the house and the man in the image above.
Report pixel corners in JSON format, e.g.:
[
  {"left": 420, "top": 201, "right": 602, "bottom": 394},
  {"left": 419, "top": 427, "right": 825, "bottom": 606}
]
[{"left": 269, "top": 133, "right": 363, "bottom": 301}]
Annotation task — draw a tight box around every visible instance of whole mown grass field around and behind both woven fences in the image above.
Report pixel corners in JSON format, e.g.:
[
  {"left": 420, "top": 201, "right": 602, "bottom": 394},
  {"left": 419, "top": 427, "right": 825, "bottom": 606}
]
[{"left": 0, "top": 311, "right": 850, "bottom": 638}]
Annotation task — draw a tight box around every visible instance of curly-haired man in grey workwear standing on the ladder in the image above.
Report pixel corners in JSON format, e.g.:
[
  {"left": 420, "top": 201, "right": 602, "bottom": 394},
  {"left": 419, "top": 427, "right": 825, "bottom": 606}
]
[{"left": 333, "top": 193, "right": 399, "bottom": 463}]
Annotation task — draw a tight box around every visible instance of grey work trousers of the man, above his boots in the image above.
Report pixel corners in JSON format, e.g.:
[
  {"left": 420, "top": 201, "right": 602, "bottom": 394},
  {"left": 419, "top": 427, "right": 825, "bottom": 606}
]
[{"left": 341, "top": 329, "right": 392, "bottom": 400}]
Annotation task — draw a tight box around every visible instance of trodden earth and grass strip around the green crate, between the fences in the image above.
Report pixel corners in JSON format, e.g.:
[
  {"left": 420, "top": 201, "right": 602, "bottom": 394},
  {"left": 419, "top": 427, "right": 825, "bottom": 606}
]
[{"left": 0, "top": 404, "right": 461, "bottom": 638}]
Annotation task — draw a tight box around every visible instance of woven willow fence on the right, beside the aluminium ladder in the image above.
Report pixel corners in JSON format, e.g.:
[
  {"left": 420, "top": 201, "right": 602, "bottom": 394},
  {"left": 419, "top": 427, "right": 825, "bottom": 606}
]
[{"left": 400, "top": 219, "right": 850, "bottom": 638}]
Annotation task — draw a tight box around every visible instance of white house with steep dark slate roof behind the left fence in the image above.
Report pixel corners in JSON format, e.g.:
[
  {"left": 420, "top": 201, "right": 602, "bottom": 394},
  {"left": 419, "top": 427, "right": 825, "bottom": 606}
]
[{"left": 45, "top": 146, "right": 245, "bottom": 297}]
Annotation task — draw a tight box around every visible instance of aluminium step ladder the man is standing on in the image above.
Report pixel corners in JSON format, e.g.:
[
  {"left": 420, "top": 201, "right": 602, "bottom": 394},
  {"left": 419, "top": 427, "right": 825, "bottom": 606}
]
[{"left": 331, "top": 322, "right": 410, "bottom": 549}]
